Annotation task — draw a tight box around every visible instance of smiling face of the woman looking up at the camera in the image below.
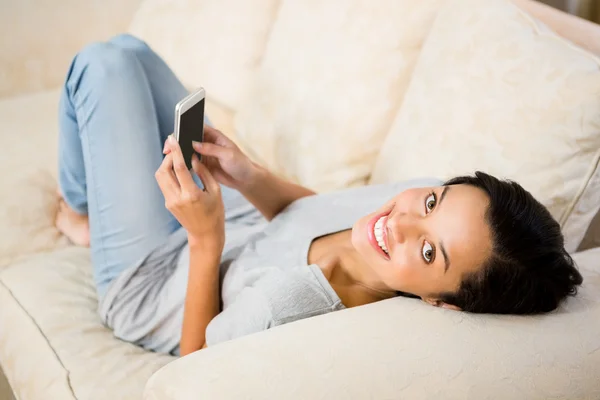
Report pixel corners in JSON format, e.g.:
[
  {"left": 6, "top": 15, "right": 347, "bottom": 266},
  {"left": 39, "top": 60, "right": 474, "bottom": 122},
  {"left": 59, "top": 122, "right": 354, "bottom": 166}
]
[{"left": 352, "top": 185, "right": 492, "bottom": 304}]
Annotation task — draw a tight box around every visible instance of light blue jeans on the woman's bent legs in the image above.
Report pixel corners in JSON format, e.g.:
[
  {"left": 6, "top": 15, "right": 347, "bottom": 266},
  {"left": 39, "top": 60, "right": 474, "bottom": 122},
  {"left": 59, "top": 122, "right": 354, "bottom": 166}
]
[{"left": 59, "top": 35, "right": 256, "bottom": 296}]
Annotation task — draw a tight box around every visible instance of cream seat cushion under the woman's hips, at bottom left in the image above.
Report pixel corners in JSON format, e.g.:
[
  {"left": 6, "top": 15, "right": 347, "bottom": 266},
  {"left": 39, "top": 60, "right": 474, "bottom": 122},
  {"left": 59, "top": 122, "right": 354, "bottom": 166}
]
[{"left": 0, "top": 247, "right": 174, "bottom": 400}]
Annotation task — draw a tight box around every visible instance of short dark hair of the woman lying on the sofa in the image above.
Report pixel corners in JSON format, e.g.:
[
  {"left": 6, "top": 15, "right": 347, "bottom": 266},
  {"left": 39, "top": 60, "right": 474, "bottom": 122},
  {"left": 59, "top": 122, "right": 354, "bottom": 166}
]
[{"left": 439, "top": 171, "right": 583, "bottom": 314}]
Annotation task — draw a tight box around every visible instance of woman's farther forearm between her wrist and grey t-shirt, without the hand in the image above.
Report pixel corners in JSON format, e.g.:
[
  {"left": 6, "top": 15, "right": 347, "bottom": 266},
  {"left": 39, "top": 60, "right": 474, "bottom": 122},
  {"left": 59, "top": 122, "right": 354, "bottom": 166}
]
[{"left": 239, "top": 163, "right": 316, "bottom": 221}]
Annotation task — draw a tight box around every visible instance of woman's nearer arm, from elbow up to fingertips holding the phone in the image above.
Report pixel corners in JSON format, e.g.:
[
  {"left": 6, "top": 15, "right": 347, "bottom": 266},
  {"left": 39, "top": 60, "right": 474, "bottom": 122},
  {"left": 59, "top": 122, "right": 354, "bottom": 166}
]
[{"left": 155, "top": 135, "right": 225, "bottom": 355}]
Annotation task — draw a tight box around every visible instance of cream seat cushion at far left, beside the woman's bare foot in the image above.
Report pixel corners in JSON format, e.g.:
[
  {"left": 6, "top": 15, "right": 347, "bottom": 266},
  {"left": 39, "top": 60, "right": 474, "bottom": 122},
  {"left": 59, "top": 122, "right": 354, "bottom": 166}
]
[{"left": 0, "top": 91, "right": 68, "bottom": 269}]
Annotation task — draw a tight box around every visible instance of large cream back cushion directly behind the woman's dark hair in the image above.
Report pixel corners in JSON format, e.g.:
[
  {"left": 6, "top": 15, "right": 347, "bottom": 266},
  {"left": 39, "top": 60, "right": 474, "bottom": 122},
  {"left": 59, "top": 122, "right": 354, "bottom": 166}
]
[{"left": 371, "top": 0, "right": 600, "bottom": 251}]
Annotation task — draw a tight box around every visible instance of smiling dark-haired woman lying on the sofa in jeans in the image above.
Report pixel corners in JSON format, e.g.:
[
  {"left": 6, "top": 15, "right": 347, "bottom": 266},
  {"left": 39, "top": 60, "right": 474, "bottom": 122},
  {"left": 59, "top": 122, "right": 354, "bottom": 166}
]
[{"left": 56, "top": 35, "right": 582, "bottom": 354}]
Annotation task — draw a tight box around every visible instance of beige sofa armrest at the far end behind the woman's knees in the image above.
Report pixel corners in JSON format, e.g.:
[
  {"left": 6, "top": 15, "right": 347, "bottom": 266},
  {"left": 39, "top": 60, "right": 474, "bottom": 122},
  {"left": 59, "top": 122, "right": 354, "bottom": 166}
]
[{"left": 0, "top": 0, "right": 141, "bottom": 98}]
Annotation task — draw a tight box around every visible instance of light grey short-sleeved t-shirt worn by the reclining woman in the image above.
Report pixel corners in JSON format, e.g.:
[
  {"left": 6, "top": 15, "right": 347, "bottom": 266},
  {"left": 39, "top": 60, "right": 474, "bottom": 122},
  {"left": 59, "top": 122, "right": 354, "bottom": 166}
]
[{"left": 100, "top": 179, "right": 441, "bottom": 354}]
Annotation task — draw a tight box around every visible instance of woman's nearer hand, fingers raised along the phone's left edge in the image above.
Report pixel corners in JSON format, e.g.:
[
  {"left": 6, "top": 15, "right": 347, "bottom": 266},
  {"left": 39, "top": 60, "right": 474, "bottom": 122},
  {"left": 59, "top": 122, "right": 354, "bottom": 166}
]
[{"left": 155, "top": 135, "right": 225, "bottom": 255}]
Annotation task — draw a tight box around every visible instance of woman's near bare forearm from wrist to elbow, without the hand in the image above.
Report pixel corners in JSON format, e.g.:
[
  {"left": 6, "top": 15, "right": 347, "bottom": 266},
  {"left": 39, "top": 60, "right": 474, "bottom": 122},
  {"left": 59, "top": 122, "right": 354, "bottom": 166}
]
[{"left": 179, "top": 242, "right": 221, "bottom": 356}]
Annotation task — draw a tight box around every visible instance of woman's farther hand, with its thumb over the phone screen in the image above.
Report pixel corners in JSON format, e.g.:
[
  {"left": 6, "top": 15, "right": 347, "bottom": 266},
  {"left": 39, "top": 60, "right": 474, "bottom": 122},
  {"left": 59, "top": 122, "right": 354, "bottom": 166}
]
[{"left": 165, "top": 125, "right": 257, "bottom": 191}]
